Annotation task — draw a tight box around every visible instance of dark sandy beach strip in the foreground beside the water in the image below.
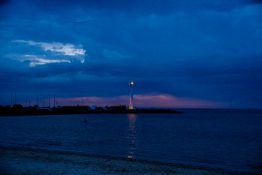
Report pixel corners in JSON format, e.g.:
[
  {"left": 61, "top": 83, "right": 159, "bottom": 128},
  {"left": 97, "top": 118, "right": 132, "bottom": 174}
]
[{"left": 0, "top": 148, "right": 255, "bottom": 175}]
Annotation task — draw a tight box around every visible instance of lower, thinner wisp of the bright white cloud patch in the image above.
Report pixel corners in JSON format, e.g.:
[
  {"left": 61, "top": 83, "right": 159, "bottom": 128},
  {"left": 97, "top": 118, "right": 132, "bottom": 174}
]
[{"left": 23, "top": 55, "right": 71, "bottom": 67}]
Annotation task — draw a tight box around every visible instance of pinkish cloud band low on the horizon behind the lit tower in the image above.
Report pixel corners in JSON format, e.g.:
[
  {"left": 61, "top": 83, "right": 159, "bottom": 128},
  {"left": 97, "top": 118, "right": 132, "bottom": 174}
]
[{"left": 57, "top": 94, "right": 222, "bottom": 108}]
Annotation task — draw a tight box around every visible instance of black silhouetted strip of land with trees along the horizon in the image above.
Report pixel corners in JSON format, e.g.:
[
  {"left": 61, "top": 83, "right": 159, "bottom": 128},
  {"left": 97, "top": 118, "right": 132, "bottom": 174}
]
[{"left": 0, "top": 104, "right": 182, "bottom": 116}]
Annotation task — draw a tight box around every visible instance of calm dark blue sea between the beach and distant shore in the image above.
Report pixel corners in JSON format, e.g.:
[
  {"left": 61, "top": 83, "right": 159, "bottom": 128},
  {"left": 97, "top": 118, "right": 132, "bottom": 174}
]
[{"left": 0, "top": 110, "right": 262, "bottom": 172}]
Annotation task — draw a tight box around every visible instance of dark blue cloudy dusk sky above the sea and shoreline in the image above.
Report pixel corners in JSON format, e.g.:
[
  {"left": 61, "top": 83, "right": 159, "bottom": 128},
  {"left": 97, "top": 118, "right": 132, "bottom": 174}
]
[{"left": 0, "top": 0, "right": 262, "bottom": 108}]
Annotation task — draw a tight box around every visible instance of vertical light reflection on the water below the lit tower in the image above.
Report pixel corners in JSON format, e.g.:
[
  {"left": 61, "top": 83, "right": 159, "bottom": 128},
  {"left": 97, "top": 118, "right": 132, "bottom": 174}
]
[{"left": 127, "top": 114, "right": 137, "bottom": 159}]
